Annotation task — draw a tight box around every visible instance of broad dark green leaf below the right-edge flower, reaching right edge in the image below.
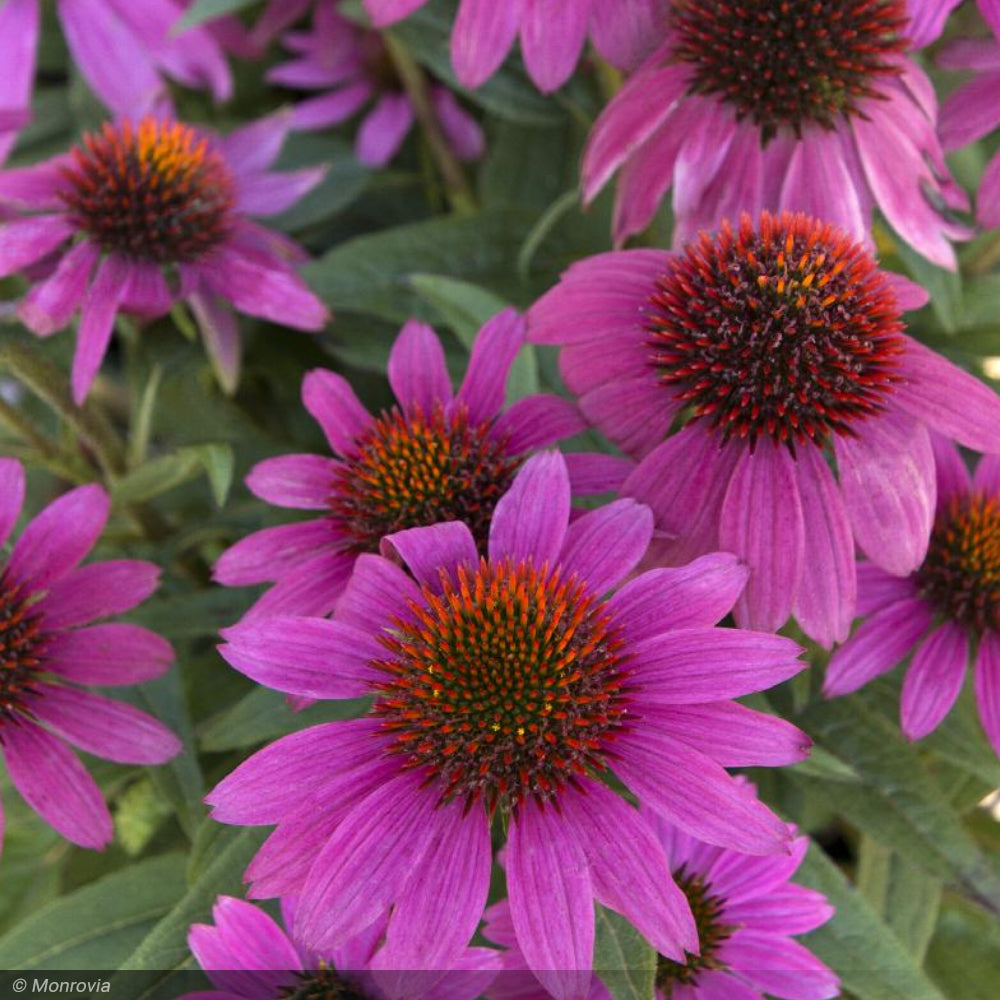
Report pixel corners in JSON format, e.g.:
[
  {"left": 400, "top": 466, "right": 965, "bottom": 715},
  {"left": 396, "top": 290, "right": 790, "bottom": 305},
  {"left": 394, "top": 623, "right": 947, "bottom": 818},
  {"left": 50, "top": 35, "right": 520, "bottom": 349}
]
[{"left": 793, "top": 696, "right": 1000, "bottom": 913}]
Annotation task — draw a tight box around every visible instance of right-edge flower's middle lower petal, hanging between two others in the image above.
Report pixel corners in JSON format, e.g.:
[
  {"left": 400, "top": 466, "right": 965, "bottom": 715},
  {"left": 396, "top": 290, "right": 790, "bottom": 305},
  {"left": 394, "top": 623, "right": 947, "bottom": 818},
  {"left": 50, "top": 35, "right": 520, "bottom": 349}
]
[{"left": 899, "top": 622, "right": 969, "bottom": 740}]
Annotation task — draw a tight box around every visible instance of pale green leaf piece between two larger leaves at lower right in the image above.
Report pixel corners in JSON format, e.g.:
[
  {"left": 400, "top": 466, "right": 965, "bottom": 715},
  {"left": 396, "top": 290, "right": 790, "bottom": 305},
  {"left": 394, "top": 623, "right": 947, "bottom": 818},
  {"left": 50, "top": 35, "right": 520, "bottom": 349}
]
[{"left": 857, "top": 837, "right": 941, "bottom": 962}]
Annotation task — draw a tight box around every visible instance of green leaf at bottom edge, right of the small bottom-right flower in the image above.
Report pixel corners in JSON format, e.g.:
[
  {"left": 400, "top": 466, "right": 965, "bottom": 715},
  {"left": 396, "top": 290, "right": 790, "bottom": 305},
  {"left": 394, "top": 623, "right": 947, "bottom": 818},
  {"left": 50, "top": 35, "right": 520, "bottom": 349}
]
[{"left": 795, "top": 844, "right": 946, "bottom": 1000}]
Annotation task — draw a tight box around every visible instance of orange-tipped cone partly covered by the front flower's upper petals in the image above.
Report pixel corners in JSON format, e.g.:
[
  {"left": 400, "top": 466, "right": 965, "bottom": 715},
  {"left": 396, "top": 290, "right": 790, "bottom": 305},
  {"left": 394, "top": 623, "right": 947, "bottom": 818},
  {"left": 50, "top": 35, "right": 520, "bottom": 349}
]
[{"left": 330, "top": 404, "right": 521, "bottom": 552}]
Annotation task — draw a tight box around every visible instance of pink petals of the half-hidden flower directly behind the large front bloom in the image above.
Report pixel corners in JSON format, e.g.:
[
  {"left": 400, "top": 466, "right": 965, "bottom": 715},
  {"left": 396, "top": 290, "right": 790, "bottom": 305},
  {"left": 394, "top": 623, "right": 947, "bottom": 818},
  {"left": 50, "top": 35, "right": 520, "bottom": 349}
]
[{"left": 214, "top": 310, "right": 629, "bottom": 617}]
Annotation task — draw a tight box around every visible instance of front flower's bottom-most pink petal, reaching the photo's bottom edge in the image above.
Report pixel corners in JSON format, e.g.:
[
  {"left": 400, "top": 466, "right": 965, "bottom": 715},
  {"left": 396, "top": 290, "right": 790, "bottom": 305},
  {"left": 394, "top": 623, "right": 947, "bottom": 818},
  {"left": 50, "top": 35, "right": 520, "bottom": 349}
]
[{"left": 507, "top": 799, "right": 594, "bottom": 1000}]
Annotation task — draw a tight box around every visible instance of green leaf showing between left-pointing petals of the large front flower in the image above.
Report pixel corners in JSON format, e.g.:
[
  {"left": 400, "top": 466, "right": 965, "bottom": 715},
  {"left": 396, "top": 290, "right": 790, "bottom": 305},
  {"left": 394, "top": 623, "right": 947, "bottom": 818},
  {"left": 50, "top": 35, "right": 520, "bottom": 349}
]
[{"left": 200, "top": 688, "right": 368, "bottom": 753}]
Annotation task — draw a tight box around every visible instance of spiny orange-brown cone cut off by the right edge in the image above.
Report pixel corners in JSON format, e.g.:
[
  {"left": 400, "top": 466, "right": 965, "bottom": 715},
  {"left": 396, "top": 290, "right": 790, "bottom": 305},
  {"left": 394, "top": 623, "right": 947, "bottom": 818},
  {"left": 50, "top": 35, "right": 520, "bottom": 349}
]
[{"left": 918, "top": 492, "right": 1000, "bottom": 634}]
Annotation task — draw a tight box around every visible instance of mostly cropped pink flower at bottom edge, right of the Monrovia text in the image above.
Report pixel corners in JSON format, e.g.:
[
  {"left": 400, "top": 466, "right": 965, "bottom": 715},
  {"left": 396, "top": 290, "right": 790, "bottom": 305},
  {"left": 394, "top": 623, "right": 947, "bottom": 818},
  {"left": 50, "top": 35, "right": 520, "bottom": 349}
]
[{"left": 182, "top": 896, "right": 499, "bottom": 1000}]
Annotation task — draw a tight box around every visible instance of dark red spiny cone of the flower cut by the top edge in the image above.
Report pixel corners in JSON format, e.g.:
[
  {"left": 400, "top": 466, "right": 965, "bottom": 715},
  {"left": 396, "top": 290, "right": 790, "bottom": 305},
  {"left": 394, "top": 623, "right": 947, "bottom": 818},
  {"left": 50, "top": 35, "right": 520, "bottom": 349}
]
[{"left": 670, "top": 0, "right": 909, "bottom": 141}]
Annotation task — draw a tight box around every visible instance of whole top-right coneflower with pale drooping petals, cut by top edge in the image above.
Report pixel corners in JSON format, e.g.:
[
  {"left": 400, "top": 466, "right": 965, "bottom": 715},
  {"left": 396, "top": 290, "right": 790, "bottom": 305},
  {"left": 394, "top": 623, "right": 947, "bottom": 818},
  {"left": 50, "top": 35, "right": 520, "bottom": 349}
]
[{"left": 583, "top": 0, "right": 969, "bottom": 268}]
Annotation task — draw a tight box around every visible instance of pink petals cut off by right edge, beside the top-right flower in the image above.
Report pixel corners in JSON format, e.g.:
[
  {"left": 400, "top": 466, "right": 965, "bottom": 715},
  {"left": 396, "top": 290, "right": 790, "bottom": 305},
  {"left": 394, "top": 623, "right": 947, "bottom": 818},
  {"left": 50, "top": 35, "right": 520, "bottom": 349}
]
[{"left": 938, "top": 36, "right": 1000, "bottom": 228}]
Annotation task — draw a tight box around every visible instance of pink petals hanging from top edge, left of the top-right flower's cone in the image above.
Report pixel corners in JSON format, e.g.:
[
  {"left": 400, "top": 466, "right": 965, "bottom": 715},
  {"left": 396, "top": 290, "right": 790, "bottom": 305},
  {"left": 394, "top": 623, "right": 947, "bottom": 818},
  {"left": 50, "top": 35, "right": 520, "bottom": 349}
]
[{"left": 365, "top": 0, "right": 662, "bottom": 92}]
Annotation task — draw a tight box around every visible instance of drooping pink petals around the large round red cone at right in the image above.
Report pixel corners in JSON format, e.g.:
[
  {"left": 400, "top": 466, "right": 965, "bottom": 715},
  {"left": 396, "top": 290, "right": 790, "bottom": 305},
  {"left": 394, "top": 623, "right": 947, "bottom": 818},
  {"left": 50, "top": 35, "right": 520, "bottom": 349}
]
[{"left": 528, "top": 213, "right": 1000, "bottom": 647}]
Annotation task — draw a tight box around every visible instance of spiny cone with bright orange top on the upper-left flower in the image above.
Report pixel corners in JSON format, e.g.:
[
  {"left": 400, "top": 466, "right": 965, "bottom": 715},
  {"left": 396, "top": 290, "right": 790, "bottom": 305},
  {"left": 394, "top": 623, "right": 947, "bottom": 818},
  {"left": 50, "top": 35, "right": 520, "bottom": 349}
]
[{"left": 61, "top": 117, "right": 235, "bottom": 264}]
